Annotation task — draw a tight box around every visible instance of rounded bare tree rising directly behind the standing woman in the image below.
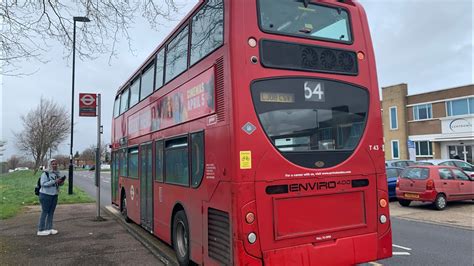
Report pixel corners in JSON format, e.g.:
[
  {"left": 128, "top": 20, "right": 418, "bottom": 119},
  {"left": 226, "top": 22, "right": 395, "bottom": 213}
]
[{"left": 16, "top": 98, "right": 70, "bottom": 173}]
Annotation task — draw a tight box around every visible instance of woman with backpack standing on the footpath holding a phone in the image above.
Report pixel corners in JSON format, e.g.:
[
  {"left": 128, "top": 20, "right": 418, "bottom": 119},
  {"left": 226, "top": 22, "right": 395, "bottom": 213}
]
[{"left": 37, "top": 159, "right": 64, "bottom": 236}]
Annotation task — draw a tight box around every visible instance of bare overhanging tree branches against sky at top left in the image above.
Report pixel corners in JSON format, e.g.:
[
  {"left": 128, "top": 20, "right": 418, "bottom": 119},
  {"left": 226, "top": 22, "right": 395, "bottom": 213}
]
[{"left": 0, "top": 0, "right": 178, "bottom": 75}]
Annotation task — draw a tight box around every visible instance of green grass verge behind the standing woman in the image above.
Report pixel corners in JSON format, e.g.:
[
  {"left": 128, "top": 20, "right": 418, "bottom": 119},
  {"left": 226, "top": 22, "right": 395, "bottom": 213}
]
[{"left": 0, "top": 171, "right": 95, "bottom": 219}]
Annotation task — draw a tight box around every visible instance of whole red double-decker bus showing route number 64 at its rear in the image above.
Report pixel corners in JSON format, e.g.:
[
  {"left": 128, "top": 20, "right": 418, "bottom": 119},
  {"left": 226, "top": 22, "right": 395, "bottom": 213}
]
[{"left": 112, "top": 0, "right": 392, "bottom": 265}]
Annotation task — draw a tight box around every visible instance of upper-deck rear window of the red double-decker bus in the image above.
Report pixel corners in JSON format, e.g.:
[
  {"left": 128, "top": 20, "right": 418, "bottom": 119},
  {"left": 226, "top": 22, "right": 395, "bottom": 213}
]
[{"left": 258, "top": 0, "right": 352, "bottom": 43}]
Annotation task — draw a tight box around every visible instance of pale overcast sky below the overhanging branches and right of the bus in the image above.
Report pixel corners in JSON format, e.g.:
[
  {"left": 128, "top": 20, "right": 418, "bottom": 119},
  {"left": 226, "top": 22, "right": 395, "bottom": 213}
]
[{"left": 0, "top": 0, "right": 474, "bottom": 161}]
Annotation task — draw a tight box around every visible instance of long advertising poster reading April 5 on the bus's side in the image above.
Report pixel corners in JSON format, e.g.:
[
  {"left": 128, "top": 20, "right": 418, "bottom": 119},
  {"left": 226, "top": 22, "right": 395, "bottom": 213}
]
[{"left": 128, "top": 68, "right": 215, "bottom": 138}]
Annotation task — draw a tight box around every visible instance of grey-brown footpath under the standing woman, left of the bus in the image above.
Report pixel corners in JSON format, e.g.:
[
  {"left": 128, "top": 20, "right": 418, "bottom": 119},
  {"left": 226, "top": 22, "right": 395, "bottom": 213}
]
[{"left": 0, "top": 204, "right": 164, "bottom": 265}]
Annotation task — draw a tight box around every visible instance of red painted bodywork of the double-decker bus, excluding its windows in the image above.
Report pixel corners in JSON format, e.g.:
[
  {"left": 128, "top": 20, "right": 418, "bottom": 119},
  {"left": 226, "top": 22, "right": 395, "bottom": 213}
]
[{"left": 112, "top": 0, "right": 392, "bottom": 265}]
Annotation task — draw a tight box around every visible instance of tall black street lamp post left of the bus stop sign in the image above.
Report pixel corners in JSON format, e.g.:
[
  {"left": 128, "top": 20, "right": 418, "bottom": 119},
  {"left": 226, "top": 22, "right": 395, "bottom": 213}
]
[{"left": 68, "top": 17, "right": 90, "bottom": 195}]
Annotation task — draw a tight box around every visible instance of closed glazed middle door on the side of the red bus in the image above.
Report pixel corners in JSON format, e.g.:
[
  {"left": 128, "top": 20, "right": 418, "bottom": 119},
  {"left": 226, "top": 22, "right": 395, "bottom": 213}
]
[{"left": 140, "top": 143, "right": 153, "bottom": 231}]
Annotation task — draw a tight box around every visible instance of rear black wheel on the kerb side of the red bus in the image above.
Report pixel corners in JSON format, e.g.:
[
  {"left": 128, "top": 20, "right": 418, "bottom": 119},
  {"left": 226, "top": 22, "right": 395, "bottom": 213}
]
[{"left": 173, "top": 211, "right": 189, "bottom": 265}]
